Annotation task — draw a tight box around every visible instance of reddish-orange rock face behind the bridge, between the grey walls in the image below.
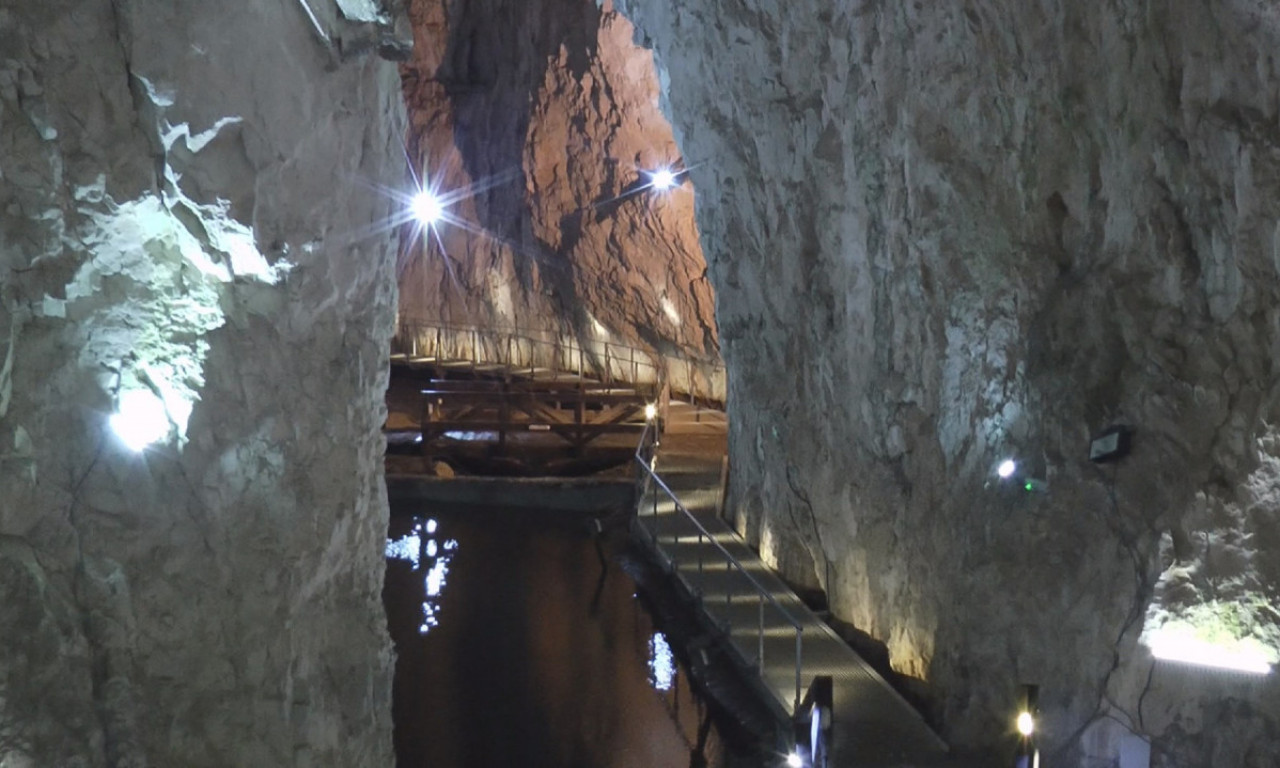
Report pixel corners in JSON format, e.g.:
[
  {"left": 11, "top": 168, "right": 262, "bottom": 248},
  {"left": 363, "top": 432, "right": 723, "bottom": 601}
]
[{"left": 399, "top": 0, "right": 718, "bottom": 360}]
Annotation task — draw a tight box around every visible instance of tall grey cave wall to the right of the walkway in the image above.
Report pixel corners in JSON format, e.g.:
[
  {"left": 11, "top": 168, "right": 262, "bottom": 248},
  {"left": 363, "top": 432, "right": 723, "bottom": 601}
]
[{"left": 620, "top": 0, "right": 1280, "bottom": 765}]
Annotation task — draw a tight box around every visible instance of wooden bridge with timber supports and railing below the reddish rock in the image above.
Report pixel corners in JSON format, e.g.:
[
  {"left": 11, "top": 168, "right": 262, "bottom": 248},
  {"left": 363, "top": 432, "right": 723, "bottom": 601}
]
[{"left": 388, "top": 320, "right": 724, "bottom": 461}]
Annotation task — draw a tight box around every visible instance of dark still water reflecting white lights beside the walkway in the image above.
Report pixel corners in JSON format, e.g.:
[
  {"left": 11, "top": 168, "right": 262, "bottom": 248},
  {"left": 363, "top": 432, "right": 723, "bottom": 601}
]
[{"left": 383, "top": 508, "right": 723, "bottom": 768}]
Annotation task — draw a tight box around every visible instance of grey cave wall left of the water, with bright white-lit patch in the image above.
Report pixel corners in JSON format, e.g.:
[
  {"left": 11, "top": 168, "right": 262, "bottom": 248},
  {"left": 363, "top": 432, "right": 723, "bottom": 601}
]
[{"left": 0, "top": 0, "right": 406, "bottom": 768}]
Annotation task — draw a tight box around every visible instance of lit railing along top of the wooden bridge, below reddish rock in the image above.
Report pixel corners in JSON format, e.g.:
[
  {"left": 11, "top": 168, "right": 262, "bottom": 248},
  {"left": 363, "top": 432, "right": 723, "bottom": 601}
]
[{"left": 392, "top": 317, "right": 727, "bottom": 403}]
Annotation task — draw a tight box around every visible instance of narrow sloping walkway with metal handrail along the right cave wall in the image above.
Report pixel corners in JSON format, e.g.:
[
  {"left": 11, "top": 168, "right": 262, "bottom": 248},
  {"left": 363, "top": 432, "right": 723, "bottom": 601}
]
[{"left": 637, "top": 403, "right": 948, "bottom": 768}]
